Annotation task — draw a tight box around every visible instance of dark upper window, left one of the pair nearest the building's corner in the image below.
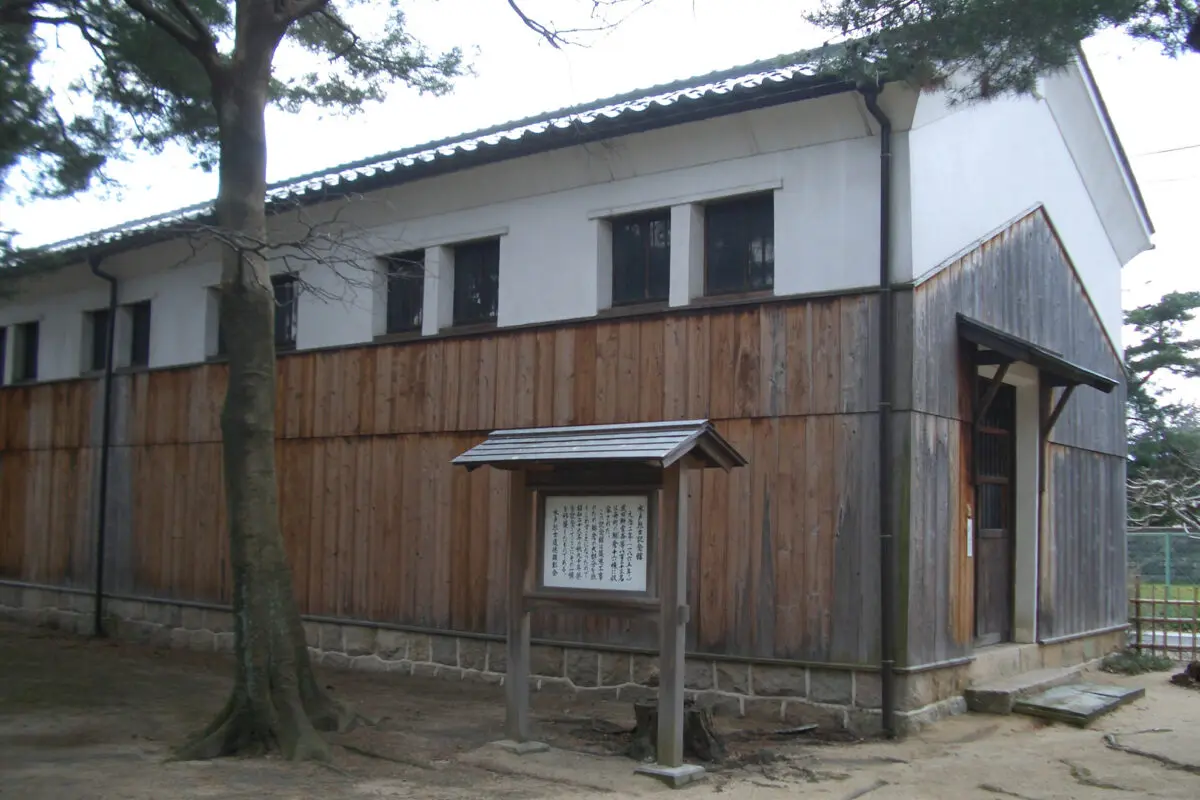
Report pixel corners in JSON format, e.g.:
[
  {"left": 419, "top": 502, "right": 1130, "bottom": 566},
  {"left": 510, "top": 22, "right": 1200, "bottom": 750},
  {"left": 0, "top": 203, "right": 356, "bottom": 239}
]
[{"left": 610, "top": 209, "right": 671, "bottom": 306}]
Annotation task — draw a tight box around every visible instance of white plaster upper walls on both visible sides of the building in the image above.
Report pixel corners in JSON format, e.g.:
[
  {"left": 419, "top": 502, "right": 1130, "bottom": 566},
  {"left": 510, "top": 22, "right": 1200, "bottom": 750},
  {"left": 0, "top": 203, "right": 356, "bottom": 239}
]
[{"left": 0, "top": 70, "right": 1142, "bottom": 379}]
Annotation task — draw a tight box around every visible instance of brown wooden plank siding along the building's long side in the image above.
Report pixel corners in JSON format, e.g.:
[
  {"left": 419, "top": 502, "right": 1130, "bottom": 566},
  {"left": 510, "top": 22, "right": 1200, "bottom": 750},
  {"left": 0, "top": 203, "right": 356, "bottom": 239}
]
[{"left": 0, "top": 294, "right": 880, "bottom": 664}]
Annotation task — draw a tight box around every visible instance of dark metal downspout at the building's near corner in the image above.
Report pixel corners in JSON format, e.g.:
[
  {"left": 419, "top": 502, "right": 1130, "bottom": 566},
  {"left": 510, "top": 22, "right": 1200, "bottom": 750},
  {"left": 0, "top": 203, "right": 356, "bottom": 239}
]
[{"left": 858, "top": 85, "right": 899, "bottom": 736}]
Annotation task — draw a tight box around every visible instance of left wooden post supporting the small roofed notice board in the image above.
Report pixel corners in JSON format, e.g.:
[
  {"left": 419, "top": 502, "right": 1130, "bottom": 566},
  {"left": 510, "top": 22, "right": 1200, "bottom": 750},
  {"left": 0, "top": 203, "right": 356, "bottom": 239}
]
[{"left": 504, "top": 470, "right": 532, "bottom": 745}]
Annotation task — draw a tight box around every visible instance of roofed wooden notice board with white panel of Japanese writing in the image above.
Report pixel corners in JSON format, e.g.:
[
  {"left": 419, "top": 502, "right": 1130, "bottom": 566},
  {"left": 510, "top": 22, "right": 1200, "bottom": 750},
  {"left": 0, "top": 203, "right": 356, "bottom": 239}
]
[{"left": 454, "top": 420, "right": 746, "bottom": 787}]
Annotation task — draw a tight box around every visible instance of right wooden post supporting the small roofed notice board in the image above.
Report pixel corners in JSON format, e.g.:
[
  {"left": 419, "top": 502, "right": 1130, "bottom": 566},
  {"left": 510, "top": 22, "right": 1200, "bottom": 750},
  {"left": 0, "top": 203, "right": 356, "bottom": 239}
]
[{"left": 658, "top": 463, "right": 688, "bottom": 768}]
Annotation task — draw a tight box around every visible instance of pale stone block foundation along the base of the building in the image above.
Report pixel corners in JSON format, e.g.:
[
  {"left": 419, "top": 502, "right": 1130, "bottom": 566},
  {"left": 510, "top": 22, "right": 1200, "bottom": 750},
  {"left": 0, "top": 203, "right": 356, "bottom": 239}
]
[{"left": 0, "top": 584, "right": 1124, "bottom": 735}]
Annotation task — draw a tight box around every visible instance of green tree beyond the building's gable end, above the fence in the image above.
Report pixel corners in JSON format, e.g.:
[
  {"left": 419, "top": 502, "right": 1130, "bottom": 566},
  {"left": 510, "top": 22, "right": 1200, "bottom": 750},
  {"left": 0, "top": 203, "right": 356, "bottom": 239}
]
[{"left": 1126, "top": 291, "right": 1200, "bottom": 529}]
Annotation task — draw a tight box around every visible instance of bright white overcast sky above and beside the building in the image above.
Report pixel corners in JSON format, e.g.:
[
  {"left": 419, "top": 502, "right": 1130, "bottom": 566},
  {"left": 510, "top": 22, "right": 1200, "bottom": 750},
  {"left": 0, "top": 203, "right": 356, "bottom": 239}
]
[{"left": 0, "top": 0, "right": 1200, "bottom": 388}]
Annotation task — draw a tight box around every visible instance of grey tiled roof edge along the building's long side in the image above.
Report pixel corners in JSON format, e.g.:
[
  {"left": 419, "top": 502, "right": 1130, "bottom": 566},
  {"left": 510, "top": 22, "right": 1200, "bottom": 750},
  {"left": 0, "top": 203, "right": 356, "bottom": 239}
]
[{"left": 28, "top": 48, "right": 850, "bottom": 260}]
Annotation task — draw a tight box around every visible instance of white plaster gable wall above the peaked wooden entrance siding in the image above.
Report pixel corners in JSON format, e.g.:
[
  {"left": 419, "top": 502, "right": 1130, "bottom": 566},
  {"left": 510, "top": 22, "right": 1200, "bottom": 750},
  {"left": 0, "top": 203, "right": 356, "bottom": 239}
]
[{"left": 908, "top": 76, "right": 1150, "bottom": 351}]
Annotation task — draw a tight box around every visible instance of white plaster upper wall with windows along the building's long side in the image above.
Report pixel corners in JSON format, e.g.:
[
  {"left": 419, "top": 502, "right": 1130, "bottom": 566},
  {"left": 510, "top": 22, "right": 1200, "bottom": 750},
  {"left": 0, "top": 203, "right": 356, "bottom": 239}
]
[{"left": 0, "top": 90, "right": 897, "bottom": 379}]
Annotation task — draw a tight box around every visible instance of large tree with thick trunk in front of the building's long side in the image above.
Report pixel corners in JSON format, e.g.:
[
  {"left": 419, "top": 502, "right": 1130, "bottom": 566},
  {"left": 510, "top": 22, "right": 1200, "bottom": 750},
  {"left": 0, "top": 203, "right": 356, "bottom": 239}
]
[{"left": 0, "top": 0, "right": 642, "bottom": 759}]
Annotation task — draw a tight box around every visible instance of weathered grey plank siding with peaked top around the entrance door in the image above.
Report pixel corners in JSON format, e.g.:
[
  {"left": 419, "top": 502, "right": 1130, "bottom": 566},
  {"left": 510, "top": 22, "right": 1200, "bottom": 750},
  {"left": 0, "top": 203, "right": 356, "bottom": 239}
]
[{"left": 901, "top": 209, "right": 1126, "bottom": 663}]
